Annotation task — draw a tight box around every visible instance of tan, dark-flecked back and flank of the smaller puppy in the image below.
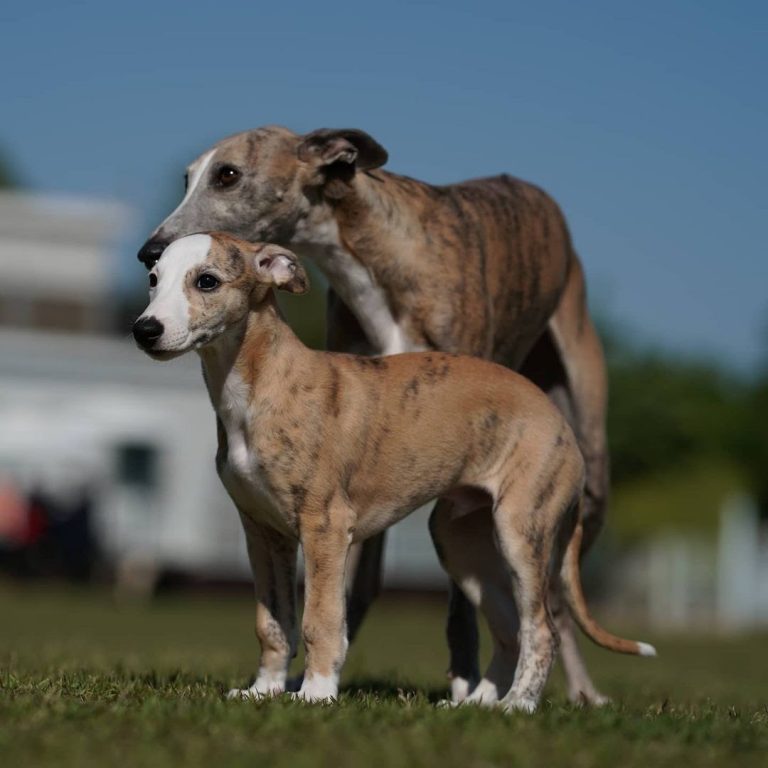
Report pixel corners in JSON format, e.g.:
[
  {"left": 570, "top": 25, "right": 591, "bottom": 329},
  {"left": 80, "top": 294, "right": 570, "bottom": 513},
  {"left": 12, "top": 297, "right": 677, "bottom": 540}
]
[{"left": 300, "top": 352, "right": 583, "bottom": 537}]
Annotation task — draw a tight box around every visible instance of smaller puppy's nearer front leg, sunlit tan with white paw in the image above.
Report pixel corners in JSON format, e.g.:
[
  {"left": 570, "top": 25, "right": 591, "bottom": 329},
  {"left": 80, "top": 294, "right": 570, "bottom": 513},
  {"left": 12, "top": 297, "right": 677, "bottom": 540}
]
[{"left": 297, "top": 505, "right": 353, "bottom": 701}]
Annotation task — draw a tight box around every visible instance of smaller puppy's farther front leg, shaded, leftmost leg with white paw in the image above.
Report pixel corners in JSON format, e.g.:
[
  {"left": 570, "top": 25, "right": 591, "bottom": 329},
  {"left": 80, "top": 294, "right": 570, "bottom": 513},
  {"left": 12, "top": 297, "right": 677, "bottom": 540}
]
[{"left": 228, "top": 513, "right": 298, "bottom": 698}]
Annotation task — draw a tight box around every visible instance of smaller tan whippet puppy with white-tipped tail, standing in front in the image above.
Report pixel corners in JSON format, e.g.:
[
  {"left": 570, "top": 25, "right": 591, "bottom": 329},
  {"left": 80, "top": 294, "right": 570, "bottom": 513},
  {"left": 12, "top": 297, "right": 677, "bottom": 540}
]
[{"left": 134, "top": 233, "right": 654, "bottom": 711}]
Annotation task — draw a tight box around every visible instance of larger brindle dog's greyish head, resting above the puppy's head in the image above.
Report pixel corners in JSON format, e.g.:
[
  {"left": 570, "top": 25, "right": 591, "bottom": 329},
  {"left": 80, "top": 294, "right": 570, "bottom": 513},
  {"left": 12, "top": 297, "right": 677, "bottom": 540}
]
[{"left": 139, "top": 126, "right": 387, "bottom": 269}]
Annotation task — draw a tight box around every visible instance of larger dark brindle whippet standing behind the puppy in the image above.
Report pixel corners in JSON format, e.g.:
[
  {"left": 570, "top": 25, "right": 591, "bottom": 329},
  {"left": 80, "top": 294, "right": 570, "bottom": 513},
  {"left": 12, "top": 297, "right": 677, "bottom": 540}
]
[{"left": 139, "top": 127, "right": 608, "bottom": 703}]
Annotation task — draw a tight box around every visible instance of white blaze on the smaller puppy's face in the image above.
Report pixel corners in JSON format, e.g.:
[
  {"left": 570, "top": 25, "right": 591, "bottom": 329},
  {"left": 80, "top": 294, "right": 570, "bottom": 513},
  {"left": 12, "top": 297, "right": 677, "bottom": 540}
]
[{"left": 142, "top": 235, "right": 213, "bottom": 352}]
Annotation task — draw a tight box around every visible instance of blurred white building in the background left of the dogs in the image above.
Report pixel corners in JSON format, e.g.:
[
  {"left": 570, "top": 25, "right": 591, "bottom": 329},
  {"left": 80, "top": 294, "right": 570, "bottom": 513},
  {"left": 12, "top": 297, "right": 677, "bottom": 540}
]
[{"left": 0, "top": 193, "right": 445, "bottom": 587}]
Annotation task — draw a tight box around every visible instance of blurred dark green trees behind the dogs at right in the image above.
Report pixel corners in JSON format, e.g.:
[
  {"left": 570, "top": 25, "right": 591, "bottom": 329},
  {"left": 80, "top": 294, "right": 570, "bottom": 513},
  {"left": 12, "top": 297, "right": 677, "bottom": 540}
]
[{"left": 604, "top": 320, "right": 768, "bottom": 506}]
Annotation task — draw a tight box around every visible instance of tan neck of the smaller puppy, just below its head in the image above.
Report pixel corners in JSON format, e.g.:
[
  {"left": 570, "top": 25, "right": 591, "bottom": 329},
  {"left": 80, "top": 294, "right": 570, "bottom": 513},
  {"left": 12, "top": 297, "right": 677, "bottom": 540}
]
[{"left": 198, "top": 291, "right": 310, "bottom": 417}]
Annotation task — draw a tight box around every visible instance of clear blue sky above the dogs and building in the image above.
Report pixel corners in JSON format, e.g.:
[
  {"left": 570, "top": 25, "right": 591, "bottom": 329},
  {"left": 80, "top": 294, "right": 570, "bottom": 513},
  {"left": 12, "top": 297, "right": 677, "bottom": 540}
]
[{"left": 0, "top": 0, "right": 768, "bottom": 369}]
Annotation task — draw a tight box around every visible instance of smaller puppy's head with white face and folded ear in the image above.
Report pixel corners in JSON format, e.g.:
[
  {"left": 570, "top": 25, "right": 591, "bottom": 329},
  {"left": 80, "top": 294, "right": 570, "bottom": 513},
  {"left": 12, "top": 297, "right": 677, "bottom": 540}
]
[{"left": 133, "top": 232, "right": 309, "bottom": 360}]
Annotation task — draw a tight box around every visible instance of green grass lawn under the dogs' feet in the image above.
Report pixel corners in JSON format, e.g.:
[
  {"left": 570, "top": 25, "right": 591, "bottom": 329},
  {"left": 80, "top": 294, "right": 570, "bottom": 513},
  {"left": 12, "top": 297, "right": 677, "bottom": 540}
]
[{"left": 0, "top": 585, "right": 768, "bottom": 768}]
